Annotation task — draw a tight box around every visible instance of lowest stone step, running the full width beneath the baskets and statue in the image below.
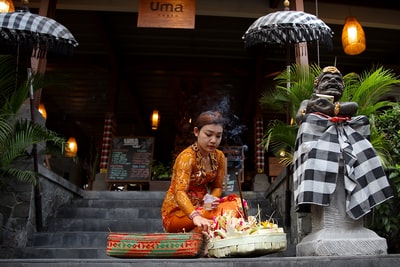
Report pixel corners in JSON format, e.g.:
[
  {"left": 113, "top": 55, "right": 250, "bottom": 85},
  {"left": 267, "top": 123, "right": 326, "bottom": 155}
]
[{"left": 0, "top": 252, "right": 400, "bottom": 267}]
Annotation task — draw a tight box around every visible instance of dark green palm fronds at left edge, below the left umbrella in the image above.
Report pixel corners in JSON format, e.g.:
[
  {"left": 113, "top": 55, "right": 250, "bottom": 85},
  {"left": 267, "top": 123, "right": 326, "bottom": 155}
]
[{"left": 0, "top": 55, "right": 65, "bottom": 187}]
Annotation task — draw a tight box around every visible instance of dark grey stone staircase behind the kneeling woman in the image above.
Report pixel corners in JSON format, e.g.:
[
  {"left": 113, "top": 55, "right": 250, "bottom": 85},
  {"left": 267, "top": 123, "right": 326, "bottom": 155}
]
[{"left": 0, "top": 191, "right": 271, "bottom": 259}]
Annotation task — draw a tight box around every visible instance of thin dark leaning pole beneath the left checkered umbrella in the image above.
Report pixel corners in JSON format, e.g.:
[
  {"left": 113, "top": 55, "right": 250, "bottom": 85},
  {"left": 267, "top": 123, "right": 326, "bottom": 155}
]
[{"left": 28, "top": 68, "right": 43, "bottom": 231}]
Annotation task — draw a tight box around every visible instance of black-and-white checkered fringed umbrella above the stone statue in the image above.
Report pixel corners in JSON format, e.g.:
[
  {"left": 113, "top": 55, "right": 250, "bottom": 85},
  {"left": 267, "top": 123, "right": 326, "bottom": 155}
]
[{"left": 242, "top": 10, "right": 333, "bottom": 48}]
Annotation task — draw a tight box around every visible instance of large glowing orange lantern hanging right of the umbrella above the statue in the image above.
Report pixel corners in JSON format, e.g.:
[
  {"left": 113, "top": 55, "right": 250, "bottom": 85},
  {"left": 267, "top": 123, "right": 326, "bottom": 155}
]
[{"left": 342, "top": 16, "right": 366, "bottom": 56}]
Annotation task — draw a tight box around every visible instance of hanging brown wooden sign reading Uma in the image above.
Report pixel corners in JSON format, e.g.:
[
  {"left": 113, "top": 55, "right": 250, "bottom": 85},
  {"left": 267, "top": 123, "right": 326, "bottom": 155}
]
[{"left": 137, "top": 0, "right": 196, "bottom": 29}]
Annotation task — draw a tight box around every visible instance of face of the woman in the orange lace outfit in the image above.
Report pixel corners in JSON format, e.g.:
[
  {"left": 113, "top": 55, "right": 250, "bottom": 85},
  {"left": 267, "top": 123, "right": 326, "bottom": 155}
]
[{"left": 194, "top": 124, "right": 223, "bottom": 155}]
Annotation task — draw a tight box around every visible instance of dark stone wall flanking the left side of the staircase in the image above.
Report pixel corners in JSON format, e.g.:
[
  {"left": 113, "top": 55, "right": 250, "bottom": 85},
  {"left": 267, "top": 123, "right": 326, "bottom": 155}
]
[{"left": 0, "top": 165, "right": 83, "bottom": 251}]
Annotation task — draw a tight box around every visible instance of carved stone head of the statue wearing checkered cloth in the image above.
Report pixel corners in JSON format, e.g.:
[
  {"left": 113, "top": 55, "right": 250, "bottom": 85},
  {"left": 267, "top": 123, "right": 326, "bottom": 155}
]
[{"left": 314, "top": 66, "right": 344, "bottom": 101}]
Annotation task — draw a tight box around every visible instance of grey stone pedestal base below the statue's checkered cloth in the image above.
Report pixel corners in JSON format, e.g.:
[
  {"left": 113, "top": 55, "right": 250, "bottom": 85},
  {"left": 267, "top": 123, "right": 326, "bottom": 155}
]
[{"left": 296, "top": 160, "right": 387, "bottom": 256}]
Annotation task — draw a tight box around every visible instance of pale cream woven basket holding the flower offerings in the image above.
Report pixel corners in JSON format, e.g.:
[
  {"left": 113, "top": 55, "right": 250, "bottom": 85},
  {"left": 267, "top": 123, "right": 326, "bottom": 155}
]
[{"left": 207, "top": 233, "right": 287, "bottom": 258}]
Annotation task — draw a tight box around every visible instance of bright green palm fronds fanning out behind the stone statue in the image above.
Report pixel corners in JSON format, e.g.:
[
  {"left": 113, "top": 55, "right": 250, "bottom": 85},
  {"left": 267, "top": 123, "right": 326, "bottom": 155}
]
[{"left": 259, "top": 64, "right": 400, "bottom": 166}]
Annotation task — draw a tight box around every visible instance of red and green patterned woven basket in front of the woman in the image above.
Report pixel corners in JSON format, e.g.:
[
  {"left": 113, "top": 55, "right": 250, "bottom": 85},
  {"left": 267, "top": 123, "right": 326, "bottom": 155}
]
[{"left": 107, "top": 232, "right": 205, "bottom": 258}]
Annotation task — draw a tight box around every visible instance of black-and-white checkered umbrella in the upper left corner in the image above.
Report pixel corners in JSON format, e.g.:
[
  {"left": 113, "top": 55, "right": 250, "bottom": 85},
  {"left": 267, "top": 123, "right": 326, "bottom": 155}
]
[{"left": 0, "top": 11, "right": 78, "bottom": 56}]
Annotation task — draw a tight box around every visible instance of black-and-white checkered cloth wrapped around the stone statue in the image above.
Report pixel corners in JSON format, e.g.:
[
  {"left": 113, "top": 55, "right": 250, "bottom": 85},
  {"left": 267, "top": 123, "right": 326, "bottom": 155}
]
[{"left": 293, "top": 113, "right": 393, "bottom": 219}]
